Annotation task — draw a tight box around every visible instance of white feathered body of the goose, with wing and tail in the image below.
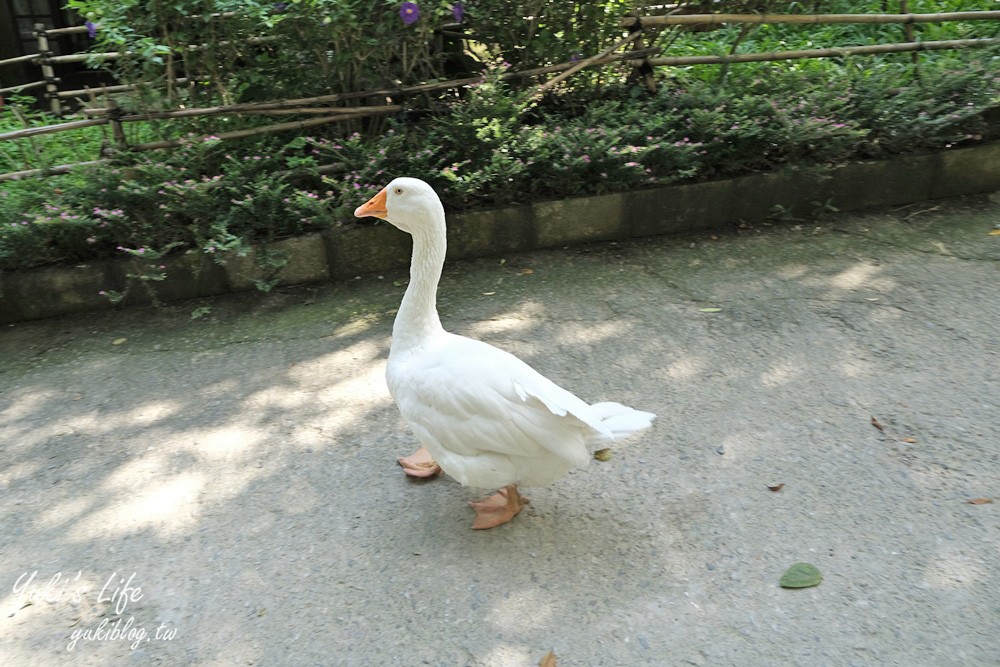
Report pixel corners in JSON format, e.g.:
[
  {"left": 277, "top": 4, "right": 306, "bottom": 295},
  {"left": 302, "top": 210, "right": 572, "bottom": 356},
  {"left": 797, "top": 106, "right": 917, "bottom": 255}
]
[{"left": 386, "top": 331, "right": 653, "bottom": 488}]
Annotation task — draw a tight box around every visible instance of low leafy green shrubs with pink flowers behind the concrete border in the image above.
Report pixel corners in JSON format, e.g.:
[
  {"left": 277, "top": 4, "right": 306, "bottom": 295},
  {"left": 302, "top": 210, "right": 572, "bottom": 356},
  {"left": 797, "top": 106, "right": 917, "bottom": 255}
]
[{"left": 0, "top": 2, "right": 1000, "bottom": 294}]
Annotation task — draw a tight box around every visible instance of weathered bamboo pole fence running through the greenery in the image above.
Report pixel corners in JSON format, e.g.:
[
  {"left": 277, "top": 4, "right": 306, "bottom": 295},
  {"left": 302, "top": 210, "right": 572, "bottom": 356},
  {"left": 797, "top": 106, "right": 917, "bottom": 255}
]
[{"left": 0, "top": 10, "right": 1000, "bottom": 181}]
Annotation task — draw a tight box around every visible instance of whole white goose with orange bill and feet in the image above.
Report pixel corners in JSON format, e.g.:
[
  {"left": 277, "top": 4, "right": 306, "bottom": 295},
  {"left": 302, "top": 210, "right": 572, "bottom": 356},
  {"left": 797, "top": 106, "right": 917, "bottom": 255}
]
[{"left": 354, "top": 178, "right": 655, "bottom": 529}]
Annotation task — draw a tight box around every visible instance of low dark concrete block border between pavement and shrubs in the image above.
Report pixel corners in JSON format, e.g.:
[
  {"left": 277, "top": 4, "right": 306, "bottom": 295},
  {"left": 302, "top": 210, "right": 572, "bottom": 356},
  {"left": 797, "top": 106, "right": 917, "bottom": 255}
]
[{"left": 0, "top": 142, "right": 1000, "bottom": 323}]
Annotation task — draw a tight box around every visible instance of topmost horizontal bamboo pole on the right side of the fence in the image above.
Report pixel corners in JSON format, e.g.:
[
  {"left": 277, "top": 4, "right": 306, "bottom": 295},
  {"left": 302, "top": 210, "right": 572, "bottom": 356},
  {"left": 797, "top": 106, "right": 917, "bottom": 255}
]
[{"left": 621, "top": 11, "right": 1000, "bottom": 28}]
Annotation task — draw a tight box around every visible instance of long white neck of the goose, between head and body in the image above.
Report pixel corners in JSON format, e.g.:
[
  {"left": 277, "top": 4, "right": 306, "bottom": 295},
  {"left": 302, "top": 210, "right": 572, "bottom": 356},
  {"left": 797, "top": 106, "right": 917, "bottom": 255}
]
[{"left": 392, "top": 211, "right": 448, "bottom": 351}]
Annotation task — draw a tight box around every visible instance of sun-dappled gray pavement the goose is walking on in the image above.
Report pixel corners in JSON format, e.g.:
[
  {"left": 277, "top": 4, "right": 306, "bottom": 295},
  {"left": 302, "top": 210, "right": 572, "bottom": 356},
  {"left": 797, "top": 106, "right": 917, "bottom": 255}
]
[{"left": 0, "top": 192, "right": 1000, "bottom": 667}]
